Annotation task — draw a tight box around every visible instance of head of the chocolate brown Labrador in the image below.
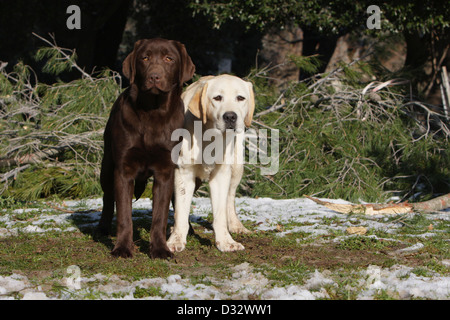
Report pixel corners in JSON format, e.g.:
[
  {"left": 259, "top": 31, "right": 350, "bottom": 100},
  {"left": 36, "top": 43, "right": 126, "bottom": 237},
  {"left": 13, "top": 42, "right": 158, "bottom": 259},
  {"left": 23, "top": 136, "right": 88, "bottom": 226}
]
[{"left": 122, "top": 38, "right": 195, "bottom": 94}]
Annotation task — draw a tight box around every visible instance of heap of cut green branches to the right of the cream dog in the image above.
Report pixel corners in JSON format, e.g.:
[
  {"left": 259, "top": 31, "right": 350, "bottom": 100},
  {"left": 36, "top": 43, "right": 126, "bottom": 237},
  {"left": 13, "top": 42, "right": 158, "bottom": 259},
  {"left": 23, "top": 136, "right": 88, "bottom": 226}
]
[{"left": 241, "top": 58, "right": 450, "bottom": 201}]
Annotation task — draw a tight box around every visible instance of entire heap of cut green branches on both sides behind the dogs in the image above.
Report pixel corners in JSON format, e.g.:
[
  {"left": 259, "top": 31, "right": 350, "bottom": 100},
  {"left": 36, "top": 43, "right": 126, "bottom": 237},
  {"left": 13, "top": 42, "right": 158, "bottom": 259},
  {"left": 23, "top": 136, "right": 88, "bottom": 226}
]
[{"left": 0, "top": 40, "right": 450, "bottom": 201}]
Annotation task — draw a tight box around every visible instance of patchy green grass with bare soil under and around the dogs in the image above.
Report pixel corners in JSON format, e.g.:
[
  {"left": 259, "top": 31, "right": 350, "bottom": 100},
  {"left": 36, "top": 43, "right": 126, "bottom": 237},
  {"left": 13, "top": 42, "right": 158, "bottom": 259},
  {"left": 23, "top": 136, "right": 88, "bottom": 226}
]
[{"left": 0, "top": 199, "right": 450, "bottom": 299}]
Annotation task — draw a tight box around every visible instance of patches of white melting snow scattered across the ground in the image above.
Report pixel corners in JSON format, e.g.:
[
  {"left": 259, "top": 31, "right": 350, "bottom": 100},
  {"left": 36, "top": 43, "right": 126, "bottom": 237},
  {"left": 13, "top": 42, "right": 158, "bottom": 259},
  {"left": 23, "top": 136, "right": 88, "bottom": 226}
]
[{"left": 0, "top": 198, "right": 450, "bottom": 300}]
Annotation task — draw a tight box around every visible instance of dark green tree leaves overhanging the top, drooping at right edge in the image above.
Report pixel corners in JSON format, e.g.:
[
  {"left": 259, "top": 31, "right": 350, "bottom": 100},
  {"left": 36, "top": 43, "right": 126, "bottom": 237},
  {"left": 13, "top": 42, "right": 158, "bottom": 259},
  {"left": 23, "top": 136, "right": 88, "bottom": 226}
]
[{"left": 191, "top": 0, "right": 450, "bottom": 96}]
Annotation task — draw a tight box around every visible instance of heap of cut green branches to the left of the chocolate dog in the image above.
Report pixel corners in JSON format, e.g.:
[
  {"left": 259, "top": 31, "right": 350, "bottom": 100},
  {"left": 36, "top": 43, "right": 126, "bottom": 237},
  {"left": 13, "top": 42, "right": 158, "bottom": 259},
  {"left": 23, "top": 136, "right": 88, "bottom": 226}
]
[{"left": 0, "top": 42, "right": 121, "bottom": 200}]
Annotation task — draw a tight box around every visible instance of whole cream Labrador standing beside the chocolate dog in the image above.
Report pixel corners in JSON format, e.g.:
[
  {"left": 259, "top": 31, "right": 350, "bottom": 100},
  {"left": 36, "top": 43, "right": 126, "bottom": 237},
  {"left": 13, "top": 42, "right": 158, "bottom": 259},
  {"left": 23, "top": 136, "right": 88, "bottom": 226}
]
[{"left": 167, "top": 75, "right": 255, "bottom": 252}]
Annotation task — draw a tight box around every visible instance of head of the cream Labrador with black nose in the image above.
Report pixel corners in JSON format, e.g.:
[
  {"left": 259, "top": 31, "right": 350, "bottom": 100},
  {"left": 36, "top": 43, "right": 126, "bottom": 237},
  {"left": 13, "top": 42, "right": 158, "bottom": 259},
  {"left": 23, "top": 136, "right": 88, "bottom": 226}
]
[{"left": 183, "top": 75, "right": 255, "bottom": 132}]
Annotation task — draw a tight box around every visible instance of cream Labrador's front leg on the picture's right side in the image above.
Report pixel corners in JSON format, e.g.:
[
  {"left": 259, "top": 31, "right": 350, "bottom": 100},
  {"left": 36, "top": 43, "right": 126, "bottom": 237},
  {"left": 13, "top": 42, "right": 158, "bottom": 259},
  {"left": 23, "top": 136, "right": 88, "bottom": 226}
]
[{"left": 209, "top": 164, "right": 244, "bottom": 252}]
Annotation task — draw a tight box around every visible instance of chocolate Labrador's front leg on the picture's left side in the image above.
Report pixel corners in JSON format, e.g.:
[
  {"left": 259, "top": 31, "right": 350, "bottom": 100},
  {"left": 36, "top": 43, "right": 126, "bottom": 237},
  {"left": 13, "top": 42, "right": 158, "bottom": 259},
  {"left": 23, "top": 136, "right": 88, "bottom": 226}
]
[{"left": 111, "top": 170, "right": 134, "bottom": 258}]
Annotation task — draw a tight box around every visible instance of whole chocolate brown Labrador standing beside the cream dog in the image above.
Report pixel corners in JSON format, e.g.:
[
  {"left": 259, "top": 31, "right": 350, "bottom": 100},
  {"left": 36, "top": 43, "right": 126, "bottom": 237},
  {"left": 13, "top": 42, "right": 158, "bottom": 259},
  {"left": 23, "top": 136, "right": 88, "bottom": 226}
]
[{"left": 98, "top": 39, "right": 195, "bottom": 259}]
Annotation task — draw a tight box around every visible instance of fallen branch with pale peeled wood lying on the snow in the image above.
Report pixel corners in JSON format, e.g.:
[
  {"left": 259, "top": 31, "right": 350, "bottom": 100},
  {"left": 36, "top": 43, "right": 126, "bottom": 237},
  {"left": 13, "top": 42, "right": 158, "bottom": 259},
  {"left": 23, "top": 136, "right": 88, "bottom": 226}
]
[{"left": 305, "top": 193, "right": 450, "bottom": 216}]
